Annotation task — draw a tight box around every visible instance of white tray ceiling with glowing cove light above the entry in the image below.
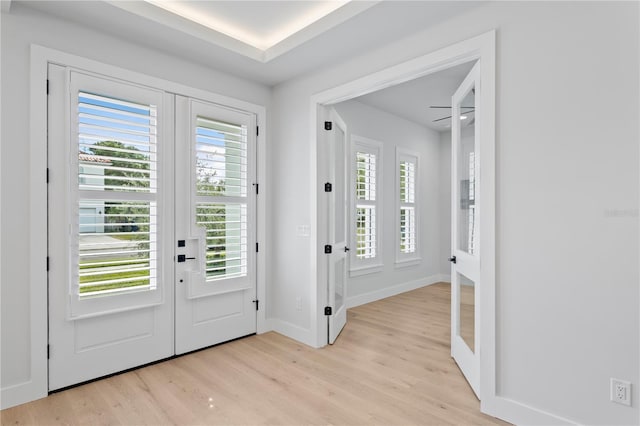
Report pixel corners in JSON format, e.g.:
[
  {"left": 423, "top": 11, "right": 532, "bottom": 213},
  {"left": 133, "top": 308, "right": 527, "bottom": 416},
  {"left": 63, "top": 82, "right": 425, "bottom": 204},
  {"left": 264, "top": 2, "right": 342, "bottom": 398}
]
[{"left": 11, "top": 0, "right": 482, "bottom": 86}]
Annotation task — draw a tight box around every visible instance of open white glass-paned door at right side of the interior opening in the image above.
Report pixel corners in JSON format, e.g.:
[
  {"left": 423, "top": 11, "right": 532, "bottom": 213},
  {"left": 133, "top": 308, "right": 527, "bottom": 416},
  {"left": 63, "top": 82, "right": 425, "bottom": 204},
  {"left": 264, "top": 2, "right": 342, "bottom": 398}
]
[{"left": 450, "top": 63, "right": 482, "bottom": 396}]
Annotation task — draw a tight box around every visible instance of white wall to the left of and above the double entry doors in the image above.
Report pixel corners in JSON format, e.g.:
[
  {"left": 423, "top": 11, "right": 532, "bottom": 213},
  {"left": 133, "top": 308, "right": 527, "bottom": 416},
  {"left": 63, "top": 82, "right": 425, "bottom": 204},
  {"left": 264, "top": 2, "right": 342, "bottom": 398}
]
[{"left": 0, "top": 3, "right": 271, "bottom": 408}]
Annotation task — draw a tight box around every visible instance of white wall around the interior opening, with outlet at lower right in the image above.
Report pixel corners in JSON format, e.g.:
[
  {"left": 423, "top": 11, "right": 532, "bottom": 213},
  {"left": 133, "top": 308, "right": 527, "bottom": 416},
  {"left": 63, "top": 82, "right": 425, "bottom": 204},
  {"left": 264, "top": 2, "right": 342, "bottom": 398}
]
[{"left": 272, "top": 2, "right": 640, "bottom": 424}]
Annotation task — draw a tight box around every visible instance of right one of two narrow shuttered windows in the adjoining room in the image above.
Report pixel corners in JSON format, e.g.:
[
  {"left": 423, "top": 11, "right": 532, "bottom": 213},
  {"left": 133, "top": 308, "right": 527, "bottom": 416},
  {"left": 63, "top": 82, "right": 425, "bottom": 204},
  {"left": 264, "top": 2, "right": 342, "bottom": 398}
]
[{"left": 396, "top": 148, "right": 420, "bottom": 266}]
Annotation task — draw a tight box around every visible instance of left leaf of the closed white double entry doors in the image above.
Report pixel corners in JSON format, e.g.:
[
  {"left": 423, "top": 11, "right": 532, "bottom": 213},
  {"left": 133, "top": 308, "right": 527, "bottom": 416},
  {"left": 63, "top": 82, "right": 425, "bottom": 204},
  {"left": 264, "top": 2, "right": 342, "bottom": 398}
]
[{"left": 43, "top": 65, "right": 173, "bottom": 390}]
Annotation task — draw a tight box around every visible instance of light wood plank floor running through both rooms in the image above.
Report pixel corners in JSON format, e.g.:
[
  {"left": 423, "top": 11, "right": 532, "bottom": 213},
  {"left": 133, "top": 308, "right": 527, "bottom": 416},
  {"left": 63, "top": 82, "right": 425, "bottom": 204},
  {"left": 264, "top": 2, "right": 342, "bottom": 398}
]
[{"left": 0, "top": 283, "right": 505, "bottom": 425}]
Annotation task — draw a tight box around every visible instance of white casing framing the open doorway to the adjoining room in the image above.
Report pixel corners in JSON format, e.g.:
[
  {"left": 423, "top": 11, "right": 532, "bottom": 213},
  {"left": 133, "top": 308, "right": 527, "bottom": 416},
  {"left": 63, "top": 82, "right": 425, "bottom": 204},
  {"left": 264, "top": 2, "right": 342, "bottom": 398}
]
[{"left": 309, "top": 30, "right": 499, "bottom": 414}]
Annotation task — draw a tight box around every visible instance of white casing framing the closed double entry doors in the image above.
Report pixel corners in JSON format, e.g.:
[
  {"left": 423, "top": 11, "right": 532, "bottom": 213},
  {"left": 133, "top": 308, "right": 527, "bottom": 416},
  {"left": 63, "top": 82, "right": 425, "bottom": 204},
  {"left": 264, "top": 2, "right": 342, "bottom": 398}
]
[{"left": 18, "top": 44, "right": 270, "bottom": 409}]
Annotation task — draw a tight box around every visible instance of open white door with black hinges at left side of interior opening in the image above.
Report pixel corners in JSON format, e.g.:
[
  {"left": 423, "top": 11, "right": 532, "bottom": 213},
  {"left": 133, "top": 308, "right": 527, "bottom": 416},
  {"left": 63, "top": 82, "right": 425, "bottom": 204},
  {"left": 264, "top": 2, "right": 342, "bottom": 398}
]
[{"left": 327, "top": 108, "right": 349, "bottom": 344}]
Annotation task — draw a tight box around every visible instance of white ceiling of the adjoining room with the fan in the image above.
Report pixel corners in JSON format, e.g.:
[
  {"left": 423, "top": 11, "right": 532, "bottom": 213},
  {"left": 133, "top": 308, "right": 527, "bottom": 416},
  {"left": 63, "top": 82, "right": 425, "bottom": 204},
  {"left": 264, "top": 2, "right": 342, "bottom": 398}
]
[{"left": 355, "top": 62, "right": 473, "bottom": 132}]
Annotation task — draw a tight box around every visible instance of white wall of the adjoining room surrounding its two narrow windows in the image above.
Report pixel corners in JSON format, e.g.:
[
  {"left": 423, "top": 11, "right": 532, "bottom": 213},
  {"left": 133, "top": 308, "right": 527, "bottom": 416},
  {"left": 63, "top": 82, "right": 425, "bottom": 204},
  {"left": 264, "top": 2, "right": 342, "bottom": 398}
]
[{"left": 335, "top": 101, "right": 440, "bottom": 306}]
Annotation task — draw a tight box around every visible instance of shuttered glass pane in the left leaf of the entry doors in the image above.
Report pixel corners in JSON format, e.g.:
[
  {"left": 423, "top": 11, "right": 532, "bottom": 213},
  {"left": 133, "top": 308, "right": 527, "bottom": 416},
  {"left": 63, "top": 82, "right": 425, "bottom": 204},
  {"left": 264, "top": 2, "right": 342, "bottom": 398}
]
[{"left": 74, "top": 91, "right": 158, "bottom": 298}]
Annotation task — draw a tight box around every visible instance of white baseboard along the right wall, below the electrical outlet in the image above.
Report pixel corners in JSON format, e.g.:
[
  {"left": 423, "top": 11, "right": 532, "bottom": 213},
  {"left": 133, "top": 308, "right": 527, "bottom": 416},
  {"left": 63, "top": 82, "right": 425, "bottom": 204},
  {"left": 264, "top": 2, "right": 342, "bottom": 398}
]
[{"left": 480, "top": 396, "right": 578, "bottom": 426}]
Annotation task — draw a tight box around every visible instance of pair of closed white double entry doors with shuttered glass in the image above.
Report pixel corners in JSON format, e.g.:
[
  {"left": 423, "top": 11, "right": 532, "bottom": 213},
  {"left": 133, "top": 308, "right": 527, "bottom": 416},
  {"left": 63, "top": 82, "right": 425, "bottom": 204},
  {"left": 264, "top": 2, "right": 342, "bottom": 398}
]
[{"left": 48, "top": 65, "right": 256, "bottom": 390}]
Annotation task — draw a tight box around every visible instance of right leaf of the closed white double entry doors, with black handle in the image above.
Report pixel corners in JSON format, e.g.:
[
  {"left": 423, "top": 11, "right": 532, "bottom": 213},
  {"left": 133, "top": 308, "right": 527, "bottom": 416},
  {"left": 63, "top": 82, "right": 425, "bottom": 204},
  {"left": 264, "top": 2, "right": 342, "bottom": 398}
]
[{"left": 175, "top": 96, "right": 258, "bottom": 354}]
